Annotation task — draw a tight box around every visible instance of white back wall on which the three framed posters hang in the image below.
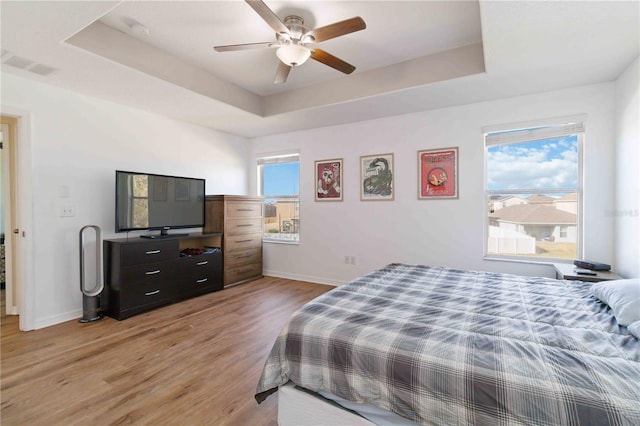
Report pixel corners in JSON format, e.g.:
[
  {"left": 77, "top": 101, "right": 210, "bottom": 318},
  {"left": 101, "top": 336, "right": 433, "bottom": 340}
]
[{"left": 249, "top": 83, "right": 615, "bottom": 284}]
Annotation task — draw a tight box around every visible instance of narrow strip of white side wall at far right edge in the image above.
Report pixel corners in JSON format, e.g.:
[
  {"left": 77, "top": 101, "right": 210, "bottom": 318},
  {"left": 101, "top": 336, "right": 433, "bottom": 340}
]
[{"left": 611, "top": 58, "right": 640, "bottom": 277}]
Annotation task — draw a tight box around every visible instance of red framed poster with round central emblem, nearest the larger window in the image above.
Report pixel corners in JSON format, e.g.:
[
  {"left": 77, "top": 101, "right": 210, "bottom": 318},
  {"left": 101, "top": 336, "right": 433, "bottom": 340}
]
[{"left": 418, "top": 147, "right": 458, "bottom": 200}]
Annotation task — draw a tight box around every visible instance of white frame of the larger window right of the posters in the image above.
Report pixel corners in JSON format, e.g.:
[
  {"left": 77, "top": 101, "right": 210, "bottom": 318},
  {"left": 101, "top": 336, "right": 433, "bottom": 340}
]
[{"left": 482, "top": 114, "right": 587, "bottom": 263}]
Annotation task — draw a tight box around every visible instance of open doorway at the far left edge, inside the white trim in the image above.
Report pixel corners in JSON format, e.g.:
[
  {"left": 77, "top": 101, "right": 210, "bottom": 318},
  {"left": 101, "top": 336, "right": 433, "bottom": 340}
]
[{"left": 0, "top": 115, "right": 20, "bottom": 315}]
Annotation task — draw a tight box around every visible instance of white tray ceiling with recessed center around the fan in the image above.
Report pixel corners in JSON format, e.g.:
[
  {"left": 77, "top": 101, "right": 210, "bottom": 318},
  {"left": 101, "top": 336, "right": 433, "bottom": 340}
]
[{"left": 0, "top": 0, "right": 640, "bottom": 137}]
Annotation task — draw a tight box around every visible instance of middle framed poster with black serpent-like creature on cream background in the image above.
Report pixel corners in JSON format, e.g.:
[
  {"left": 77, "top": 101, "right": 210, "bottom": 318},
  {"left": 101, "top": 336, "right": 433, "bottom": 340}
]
[{"left": 360, "top": 154, "right": 394, "bottom": 201}]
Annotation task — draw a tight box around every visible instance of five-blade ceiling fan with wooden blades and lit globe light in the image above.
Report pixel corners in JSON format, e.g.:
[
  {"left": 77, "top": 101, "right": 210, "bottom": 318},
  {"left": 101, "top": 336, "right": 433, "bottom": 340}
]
[{"left": 214, "top": 0, "right": 367, "bottom": 84}]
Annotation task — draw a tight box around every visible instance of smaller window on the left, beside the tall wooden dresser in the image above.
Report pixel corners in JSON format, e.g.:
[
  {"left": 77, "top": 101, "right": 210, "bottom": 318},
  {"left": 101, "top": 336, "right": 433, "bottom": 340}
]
[{"left": 258, "top": 153, "right": 300, "bottom": 243}]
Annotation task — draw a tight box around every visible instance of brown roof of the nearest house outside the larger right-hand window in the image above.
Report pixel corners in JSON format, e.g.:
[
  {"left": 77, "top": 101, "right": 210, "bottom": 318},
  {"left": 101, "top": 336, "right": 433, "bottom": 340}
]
[{"left": 489, "top": 204, "right": 577, "bottom": 225}]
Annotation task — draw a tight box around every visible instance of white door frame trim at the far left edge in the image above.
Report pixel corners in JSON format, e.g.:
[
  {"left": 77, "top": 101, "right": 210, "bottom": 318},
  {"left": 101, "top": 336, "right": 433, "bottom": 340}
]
[{"left": 0, "top": 105, "right": 35, "bottom": 331}]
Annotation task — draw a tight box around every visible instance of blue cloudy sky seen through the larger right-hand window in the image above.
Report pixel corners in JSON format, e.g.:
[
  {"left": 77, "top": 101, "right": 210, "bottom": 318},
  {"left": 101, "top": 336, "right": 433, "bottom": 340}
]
[{"left": 487, "top": 136, "right": 578, "bottom": 190}]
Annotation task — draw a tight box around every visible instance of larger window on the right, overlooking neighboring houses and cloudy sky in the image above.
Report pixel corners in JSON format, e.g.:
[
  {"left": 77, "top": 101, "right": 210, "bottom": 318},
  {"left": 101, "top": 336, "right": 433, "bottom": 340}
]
[{"left": 485, "top": 121, "right": 584, "bottom": 260}]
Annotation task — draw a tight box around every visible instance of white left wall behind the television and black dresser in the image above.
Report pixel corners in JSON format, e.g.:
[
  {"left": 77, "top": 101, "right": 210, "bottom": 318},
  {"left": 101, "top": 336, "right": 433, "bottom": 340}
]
[{"left": 2, "top": 73, "right": 248, "bottom": 328}]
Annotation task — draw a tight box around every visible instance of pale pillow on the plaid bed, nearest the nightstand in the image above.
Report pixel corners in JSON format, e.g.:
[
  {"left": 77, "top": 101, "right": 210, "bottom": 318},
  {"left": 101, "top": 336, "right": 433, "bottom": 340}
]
[{"left": 591, "top": 278, "right": 640, "bottom": 325}]
